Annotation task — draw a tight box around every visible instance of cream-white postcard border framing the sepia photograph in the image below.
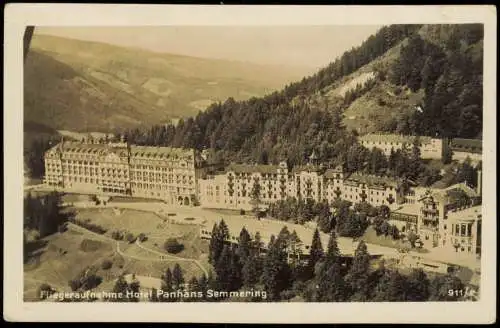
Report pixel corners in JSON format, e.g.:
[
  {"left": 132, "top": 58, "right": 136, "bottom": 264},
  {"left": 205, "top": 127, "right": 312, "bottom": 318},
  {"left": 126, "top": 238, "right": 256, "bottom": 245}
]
[{"left": 3, "top": 4, "right": 497, "bottom": 324}]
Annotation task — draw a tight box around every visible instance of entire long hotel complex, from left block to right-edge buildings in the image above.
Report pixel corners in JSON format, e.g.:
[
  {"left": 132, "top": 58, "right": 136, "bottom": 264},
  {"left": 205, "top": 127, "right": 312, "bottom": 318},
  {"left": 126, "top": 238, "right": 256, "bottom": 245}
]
[{"left": 45, "top": 138, "right": 481, "bottom": 254}]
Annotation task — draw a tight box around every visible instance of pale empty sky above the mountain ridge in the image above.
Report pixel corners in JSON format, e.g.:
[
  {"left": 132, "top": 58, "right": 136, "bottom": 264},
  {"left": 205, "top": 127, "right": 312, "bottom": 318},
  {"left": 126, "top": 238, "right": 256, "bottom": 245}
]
[{"left": 35, "top": 25, "right": 381, "bottom": 68}]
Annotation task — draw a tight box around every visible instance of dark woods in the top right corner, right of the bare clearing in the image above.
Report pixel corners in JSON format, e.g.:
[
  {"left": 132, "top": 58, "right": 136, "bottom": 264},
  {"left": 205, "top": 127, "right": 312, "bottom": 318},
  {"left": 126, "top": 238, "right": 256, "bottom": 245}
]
[{"left": 389, "top": 24, "right": 483, "bottom": 138}]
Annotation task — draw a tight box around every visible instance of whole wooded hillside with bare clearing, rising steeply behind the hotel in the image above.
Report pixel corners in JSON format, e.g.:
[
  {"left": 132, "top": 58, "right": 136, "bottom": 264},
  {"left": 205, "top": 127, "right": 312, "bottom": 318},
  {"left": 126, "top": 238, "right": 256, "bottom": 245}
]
[{"left": 121, "top": 25, "right": 482, "bottom": 168}]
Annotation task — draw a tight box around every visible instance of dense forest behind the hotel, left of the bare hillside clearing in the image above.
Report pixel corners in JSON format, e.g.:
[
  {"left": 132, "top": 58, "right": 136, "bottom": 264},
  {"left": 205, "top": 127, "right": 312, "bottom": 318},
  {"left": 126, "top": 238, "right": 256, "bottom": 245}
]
[{"left": 125, "top": 25, "right": 420, "bottom": 164}]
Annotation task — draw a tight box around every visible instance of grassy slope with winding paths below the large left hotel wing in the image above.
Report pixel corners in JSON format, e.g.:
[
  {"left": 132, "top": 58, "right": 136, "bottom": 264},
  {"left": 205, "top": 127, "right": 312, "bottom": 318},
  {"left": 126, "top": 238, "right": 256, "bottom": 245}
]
[{"left": 24, "top": 222, "right": 206, "bottom": 301}]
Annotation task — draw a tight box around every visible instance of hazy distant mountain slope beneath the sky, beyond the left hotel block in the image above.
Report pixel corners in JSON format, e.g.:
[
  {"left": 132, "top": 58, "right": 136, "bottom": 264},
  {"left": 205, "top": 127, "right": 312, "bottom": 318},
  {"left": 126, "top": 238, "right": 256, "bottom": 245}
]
[{"left": 24, "top": 34, "right": 306, "bottom": 131}]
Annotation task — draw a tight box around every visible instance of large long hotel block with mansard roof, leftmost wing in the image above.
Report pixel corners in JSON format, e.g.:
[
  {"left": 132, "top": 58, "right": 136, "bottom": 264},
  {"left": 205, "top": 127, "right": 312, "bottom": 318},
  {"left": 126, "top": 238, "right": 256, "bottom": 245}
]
[{"left": 44, "top": 141, "right": 202, "bottom": 205}]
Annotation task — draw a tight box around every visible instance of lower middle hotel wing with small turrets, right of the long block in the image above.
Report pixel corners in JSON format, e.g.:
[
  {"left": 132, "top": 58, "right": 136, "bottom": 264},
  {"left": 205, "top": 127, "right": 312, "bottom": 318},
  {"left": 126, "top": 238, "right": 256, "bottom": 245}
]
[{"left": 199, "top": 162, "right": 404, "bottom": 210}]
